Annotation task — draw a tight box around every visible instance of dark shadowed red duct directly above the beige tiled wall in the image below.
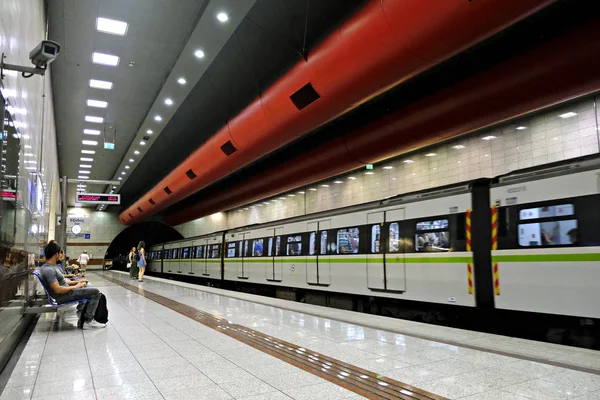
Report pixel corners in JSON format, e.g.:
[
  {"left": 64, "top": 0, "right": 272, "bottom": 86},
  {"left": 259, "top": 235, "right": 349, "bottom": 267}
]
[{"left": 166, "top": 21, "right": 600, "bottom": 225}]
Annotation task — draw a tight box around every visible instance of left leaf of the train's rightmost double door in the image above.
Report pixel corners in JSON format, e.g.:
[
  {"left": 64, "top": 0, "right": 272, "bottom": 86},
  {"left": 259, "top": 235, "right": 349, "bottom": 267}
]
[{"left": 367, "top": 211, "right": 386, "bottom": 290}]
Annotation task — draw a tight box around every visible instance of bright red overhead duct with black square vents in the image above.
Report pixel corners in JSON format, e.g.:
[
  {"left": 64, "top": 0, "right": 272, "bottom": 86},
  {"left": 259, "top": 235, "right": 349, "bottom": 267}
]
[{"left": 120, "top": 0, "right": 555, "bottom": 224}]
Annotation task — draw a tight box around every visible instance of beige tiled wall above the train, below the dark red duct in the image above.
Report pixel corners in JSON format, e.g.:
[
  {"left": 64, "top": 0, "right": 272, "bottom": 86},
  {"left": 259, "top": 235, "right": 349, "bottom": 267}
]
[{"left": 176, "top": 97, "right": 600, "bottom": 237}]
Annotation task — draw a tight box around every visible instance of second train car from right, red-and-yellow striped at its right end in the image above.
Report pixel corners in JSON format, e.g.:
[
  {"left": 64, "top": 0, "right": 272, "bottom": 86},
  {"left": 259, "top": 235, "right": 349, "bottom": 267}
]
[{"left": 224, "top": 181, "right": 492, "bottom": 307}]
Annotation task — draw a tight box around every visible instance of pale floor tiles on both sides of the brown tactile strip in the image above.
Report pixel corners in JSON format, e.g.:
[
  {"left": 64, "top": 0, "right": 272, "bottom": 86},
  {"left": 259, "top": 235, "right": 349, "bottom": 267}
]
[{"left": 0, "top": 274, "right": 600, "bottom": 400}]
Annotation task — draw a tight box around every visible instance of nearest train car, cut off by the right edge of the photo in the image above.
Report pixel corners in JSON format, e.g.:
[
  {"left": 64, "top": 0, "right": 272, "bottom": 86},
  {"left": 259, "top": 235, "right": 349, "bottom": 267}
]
[{"left": 490, "top": 159, "right": 600, "bottom": 318}]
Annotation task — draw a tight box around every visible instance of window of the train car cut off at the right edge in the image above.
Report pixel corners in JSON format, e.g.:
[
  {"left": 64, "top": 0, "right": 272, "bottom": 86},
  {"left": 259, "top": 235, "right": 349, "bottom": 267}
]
[{"left": 519, "top": 219, "right": 579, "bottom": 247}]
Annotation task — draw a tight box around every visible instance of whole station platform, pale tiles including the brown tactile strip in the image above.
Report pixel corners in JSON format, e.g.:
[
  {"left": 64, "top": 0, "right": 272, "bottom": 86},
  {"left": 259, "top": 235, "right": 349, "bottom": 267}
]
[{"left": 0, "top": 271, "right": 600, "bottom": 400}]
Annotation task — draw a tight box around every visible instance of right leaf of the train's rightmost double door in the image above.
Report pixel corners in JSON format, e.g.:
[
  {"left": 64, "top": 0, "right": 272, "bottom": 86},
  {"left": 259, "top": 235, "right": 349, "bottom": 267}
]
[{"left": 382, "top": 208, "right": 406, "bottom": 292}]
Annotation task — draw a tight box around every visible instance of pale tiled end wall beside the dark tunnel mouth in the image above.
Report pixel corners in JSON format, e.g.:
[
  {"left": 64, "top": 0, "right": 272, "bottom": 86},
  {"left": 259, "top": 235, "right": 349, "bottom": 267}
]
[{"left": 67, "top": 207, "right": 127, "bottom": 269}]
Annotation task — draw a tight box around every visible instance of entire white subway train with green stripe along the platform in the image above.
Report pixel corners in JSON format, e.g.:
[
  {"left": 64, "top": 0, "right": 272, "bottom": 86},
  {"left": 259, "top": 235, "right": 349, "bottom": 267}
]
[{"left": 147, "top": 158, "right": 600, "bottom": 324}]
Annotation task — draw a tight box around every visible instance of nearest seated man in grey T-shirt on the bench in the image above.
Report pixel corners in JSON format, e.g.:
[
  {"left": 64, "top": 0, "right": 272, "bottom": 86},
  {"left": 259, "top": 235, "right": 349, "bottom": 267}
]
[{"left": 40, "top": 243, "right": 100, "bottom": 329}]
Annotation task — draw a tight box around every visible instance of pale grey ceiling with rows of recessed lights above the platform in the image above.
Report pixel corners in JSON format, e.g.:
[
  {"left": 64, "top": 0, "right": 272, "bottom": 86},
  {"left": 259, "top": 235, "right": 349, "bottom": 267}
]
[{"left": 49, "top": 0, "right": 254, "bottom": 206}]
